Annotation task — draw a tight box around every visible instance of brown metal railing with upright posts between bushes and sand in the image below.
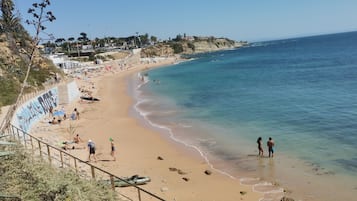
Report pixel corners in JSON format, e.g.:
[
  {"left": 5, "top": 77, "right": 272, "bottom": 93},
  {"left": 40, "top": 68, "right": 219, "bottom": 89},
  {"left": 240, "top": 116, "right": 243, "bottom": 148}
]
[{"left": 3, "top": 124, "right": 164, "bottom": 201}]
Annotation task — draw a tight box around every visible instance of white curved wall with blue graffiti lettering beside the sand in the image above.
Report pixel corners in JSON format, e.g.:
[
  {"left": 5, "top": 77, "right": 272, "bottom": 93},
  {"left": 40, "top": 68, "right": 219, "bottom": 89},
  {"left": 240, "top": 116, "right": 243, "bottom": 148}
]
[{"left": 12, "top": 87, "right": 58, "bottom": 132}]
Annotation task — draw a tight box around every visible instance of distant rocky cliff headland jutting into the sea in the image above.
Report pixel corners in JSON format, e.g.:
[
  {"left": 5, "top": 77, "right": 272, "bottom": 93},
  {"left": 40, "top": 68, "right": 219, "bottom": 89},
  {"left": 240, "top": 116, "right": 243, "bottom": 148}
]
[{"left": 141, "top": 37, "right": 247, "bottom": 57}]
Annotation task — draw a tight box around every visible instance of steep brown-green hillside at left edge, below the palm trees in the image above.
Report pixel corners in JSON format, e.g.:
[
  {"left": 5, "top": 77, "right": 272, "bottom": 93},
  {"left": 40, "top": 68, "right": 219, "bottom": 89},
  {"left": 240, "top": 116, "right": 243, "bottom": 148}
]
[{"left": 0, "top": 29, "right": 59, "bottom": 106}]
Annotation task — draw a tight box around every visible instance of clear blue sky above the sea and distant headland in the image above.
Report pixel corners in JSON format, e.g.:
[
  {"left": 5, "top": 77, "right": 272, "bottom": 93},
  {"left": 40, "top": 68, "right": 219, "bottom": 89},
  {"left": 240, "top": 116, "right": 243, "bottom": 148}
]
[{"left": 14, "top": 0, "right": 357, "bottom": 41}]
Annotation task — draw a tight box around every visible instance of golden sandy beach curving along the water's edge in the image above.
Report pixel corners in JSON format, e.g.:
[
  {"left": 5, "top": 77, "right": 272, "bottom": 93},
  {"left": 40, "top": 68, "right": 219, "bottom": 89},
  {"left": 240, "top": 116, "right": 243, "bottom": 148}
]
[{"left": 31, "top": 58, "right": 264, "bottom": 201}]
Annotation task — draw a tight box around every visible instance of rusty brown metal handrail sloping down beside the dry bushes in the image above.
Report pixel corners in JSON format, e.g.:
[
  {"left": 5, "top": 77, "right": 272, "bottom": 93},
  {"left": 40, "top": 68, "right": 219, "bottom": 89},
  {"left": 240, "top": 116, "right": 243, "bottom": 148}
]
[{"left": 7, "top": 124, "right": 165, "bottom": 201}]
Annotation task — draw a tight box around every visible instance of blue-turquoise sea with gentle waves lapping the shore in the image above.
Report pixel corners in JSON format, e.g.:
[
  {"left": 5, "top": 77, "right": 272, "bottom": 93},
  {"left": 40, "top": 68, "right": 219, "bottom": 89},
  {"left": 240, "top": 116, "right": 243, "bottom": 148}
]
[{"left": 131, "top": 32, "right": 357, "bottom": 201}]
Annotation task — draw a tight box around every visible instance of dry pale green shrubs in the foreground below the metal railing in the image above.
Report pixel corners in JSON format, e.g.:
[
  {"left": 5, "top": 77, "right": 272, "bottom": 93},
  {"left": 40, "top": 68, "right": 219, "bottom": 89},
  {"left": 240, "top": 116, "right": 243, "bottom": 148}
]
[{"left": 0, "top": 148, "right": 118, "bottom": 201}]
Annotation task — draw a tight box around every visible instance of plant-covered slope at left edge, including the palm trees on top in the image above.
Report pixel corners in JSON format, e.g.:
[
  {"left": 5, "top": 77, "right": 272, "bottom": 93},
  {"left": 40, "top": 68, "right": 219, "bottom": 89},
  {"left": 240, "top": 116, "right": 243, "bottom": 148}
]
[{"left": 0, "top": 0, "right": 60, "bottom": 105}]
